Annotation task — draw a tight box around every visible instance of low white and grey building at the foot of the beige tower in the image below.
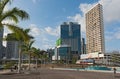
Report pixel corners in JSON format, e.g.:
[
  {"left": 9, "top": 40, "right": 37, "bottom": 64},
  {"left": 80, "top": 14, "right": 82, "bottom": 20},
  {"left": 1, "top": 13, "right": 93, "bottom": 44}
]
[{"left": 80, "top": 53, "right": 120, "bottom": 66}]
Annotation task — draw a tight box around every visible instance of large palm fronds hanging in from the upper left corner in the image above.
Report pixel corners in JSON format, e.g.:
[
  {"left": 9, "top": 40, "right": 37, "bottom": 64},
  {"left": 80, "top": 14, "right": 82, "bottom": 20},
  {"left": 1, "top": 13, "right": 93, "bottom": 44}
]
[{"left": 0, "top": 0, "right": 29, "bottom": 31}]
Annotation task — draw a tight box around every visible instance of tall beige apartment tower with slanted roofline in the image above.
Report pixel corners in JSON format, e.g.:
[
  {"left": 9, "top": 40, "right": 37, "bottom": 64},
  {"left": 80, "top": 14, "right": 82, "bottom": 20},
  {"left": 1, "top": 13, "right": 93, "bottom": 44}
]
[{"left": 85, "top": 4, "right": 105, "bottom": 53}]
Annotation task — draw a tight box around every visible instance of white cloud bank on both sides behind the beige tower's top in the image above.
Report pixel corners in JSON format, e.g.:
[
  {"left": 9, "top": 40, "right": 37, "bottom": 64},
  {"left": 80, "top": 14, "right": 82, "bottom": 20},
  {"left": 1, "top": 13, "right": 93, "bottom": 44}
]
[{"left": 68, "top": 0, "right": 120, "bottom": 32}]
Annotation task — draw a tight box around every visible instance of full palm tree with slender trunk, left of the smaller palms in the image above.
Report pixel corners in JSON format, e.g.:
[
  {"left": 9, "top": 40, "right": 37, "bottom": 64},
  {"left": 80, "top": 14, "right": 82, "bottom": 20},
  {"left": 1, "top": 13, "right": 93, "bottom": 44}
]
[{"left": 5, "top": 29, "right": 33, "bottom": 73}]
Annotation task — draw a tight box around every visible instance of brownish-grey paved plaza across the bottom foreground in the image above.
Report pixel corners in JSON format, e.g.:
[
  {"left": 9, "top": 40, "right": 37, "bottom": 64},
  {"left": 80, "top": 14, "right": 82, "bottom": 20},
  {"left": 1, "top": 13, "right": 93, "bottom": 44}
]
[{"left": 0, "top": 69, "right": 120, "bottom": 79}]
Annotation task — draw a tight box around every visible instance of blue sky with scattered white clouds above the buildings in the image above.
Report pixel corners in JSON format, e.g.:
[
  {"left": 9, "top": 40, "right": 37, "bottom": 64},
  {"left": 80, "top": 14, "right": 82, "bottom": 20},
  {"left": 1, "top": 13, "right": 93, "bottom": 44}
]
[{"left": 4, "top": 0, "right": 120, "bottom": 52}]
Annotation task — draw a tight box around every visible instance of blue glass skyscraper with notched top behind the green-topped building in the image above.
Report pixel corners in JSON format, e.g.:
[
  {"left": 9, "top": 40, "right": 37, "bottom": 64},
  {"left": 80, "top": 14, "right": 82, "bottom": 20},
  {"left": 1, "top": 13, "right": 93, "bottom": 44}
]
[{"left": 60, "top": 22, "right": 81, "bottom": 55}]
